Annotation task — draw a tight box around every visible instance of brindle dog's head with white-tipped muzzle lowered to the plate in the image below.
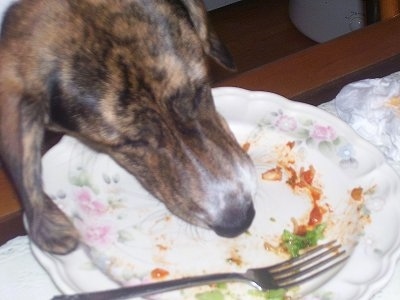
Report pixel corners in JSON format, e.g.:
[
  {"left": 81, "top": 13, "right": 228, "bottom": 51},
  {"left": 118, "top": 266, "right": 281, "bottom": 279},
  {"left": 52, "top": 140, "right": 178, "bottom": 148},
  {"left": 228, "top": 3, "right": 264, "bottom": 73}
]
[{"left": 0, "top": 0, "right": 255, "bottom": 251}]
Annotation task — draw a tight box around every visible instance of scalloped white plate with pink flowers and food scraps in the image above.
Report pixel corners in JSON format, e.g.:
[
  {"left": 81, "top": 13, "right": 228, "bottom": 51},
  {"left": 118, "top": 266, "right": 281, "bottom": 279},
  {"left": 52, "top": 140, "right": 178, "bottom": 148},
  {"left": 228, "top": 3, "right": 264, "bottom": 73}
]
[{"left": 33, "top": 88, "right": 400, "bottom": 300}]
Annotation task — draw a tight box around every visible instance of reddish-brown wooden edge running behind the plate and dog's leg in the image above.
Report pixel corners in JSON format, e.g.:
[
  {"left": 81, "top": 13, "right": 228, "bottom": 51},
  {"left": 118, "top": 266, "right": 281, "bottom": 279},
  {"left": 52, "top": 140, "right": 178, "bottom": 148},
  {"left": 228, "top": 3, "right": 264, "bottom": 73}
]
[{"left": 0, "top": 17, "right": 400, "bottom": 244}]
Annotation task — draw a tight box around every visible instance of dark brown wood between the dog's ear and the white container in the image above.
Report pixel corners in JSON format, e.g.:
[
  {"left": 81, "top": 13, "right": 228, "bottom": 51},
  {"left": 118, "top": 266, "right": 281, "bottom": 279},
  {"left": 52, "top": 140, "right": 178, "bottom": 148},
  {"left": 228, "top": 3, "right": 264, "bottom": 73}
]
[{"left": 209, "top": 0, "right": 317, "bottom": 82}]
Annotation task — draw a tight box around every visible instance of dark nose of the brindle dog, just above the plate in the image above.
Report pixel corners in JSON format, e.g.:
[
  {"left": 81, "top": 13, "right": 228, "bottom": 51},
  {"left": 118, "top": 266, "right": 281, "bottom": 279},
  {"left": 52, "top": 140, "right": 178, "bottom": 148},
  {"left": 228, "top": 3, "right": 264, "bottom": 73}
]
[{"left": 212, "top": 202, "right": 255, "bottom": 238}]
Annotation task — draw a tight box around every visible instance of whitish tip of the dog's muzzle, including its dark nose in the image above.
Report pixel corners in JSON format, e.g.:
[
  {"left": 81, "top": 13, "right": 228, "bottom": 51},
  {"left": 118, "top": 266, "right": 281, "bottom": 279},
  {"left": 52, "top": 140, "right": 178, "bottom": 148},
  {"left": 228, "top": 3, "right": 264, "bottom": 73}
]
[{"left": 178, "top": 135, "right": 256, "bottom": 238}]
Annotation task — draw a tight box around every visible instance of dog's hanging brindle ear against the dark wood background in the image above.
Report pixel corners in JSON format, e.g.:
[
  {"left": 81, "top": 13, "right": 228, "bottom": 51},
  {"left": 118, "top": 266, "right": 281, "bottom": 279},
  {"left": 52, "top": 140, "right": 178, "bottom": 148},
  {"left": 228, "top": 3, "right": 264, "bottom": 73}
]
[{"left": 181, "top": 0, "right": 236, "bottom": 71}]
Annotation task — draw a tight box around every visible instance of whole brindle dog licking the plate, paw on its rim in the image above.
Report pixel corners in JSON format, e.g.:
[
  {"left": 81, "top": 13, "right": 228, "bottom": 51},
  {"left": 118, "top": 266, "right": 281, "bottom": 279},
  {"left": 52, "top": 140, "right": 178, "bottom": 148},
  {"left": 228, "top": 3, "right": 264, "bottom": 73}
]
[{"left": 0, "top": 0, "right": 255, "bottom": 254}]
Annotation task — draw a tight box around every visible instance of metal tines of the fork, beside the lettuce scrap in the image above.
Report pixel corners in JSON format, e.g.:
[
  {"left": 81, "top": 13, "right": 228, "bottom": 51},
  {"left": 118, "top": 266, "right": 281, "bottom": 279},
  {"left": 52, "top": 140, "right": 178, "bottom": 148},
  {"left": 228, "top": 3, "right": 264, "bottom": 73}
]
[{"left": 268, "top": 241, "right": 348, "bottom": 288}]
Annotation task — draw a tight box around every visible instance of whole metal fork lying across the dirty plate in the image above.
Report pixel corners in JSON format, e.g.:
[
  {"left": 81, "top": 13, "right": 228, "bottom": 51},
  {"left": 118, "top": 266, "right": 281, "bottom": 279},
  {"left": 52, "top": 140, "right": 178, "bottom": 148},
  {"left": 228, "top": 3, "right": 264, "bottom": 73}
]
[{"left": 53, "top": 241, "right": 348, "bottom": 300}]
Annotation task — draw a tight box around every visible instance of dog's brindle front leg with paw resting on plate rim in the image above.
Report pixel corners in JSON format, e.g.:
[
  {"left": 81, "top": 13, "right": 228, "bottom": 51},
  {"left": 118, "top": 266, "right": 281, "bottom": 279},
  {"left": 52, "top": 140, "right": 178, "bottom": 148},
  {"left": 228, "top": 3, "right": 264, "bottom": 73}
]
[{"left": 0, "top": 61, "right": 79, "bottom": 254}]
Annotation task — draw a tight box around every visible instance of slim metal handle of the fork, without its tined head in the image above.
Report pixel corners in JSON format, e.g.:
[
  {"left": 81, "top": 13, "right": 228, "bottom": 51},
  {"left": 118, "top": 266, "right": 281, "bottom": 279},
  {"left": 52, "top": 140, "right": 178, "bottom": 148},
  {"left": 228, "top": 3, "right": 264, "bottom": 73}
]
[{"left": 52, "top": 273, "right": 248, "bottom": 300}]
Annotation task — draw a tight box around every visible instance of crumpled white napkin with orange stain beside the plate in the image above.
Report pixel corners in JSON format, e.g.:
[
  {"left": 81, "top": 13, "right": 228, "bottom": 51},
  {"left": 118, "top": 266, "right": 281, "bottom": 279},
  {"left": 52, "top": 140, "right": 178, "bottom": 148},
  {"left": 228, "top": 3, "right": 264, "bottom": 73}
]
[{"left": 334, "top": 72, "right": 400, "bottom": 163}]
